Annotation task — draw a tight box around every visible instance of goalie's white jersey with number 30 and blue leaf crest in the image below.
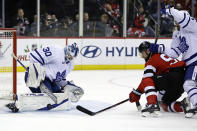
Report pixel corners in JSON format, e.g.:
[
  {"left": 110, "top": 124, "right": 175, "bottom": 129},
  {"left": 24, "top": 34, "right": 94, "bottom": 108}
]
[{"left": 30, "top": 45, "right": 74, "bottom": 86}]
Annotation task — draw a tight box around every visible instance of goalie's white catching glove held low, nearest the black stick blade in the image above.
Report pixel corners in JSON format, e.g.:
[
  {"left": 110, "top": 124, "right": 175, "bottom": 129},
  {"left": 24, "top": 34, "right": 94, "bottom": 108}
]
[{"left": 64, "top": 81, "right": 84, "bottom": 102}]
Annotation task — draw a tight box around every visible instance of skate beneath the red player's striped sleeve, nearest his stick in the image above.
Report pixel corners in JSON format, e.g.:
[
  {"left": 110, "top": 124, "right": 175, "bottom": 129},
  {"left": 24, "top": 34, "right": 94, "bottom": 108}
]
[{"left": 141, "top": 104, "right": 161, "bottom": 117}]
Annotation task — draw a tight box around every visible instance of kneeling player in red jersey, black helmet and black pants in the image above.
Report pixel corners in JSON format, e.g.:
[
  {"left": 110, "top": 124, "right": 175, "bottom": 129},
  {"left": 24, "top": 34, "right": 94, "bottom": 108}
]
[{"left": 129, "top": 41, "right": 188, "bottom": 116}]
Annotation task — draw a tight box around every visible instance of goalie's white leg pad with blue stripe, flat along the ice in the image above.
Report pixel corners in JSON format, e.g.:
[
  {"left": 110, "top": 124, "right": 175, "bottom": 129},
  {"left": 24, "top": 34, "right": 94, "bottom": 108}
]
[{"left": 12, "top": 93, "right": 71, "bottom": 111}]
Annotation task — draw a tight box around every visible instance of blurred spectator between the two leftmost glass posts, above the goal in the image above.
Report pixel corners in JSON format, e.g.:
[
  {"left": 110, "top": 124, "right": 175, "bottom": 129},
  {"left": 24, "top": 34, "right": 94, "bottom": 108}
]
[{"left": 16, "top": 8, "right": 30, "bottom": 36}]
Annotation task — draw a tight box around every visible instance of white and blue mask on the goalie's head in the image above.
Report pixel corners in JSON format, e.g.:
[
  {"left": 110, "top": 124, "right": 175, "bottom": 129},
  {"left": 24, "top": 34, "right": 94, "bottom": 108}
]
[{"left": 64, "top": 43, "right": 79, "bottom": 62}]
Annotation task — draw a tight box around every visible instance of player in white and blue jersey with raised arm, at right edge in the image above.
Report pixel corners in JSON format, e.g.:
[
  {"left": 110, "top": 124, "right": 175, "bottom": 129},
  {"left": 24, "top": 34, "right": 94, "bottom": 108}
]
[{"left": 150, "top": 5, "right": 197, "bottom": 117}]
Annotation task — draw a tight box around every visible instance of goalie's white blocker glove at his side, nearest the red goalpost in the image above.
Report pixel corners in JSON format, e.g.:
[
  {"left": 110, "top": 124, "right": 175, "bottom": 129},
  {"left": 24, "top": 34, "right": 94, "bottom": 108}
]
[{"left": 25, "top": 63, "right": 45, "bottom": 88}]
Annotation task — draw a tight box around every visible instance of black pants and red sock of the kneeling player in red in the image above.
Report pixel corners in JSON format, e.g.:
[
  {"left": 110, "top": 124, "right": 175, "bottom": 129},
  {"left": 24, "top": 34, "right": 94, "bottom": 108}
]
[{"left": 153, "top": 67, "right": 185, "bottom": 112}]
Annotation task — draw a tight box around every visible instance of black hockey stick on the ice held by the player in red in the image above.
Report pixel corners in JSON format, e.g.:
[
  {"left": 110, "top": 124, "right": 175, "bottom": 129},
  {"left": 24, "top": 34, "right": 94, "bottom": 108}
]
[{"left": 76, "top": 98, "right": 141, "bottom": 116}]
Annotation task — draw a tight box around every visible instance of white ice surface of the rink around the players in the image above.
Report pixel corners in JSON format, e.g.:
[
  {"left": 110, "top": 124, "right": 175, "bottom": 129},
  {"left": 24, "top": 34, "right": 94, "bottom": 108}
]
[{"left": 0, "top": 70, "right": 197, "bottom": 131}]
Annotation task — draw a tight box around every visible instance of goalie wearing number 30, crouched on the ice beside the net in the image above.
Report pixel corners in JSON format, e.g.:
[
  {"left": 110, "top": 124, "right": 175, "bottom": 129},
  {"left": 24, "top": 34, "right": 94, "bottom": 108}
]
[{"left": 7, "top": 43, "right": 84, "bottom": 112}]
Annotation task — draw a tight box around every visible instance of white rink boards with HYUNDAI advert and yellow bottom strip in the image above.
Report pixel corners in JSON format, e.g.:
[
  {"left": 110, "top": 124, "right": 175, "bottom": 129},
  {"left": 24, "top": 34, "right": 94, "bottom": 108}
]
[{"left": 0, "top": 37, "right": 171, "bottom": 72}]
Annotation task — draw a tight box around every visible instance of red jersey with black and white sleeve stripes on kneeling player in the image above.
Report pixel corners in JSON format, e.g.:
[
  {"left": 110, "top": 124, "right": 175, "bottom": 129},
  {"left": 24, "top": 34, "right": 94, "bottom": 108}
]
[{"left": 138, "top": 54, "right": 185, "bottom": 104}]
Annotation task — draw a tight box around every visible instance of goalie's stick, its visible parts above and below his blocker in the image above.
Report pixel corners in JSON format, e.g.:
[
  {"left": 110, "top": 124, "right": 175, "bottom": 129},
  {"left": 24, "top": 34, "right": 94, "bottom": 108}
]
[{"left": 11, "top": 52, "right": 57, "bottom": 104}]
